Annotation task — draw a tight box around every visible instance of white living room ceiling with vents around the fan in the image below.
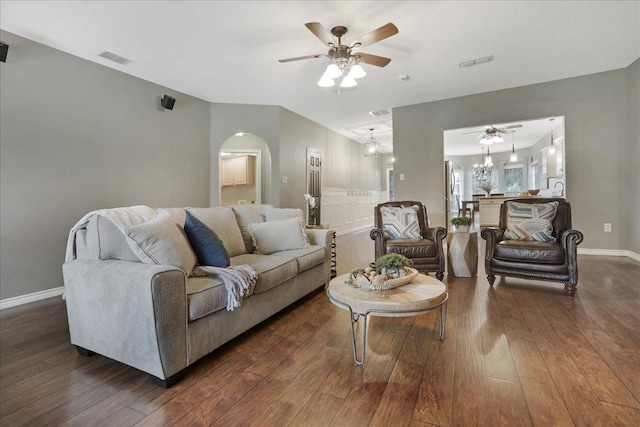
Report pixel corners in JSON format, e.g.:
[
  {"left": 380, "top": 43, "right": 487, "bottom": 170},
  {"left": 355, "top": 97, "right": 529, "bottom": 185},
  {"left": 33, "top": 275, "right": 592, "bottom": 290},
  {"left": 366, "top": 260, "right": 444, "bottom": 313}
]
[{"left": 0, "top": 0, "right": 640, "bottom": 155}]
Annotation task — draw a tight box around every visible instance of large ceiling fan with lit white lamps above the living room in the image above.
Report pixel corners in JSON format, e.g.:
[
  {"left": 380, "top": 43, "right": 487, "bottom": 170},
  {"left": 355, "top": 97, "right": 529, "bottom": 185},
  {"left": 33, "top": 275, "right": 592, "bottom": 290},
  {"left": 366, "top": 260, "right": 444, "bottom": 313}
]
[{"left": 279, "top": 22, "right": 398, "bottom": 87}]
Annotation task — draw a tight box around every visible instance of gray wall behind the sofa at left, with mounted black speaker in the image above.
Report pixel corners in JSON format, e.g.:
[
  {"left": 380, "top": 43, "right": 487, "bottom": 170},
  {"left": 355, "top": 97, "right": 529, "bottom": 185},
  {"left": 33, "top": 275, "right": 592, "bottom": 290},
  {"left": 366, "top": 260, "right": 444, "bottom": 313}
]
[{"left": 0, "top": 31, "right": 210, "bottom": 299}]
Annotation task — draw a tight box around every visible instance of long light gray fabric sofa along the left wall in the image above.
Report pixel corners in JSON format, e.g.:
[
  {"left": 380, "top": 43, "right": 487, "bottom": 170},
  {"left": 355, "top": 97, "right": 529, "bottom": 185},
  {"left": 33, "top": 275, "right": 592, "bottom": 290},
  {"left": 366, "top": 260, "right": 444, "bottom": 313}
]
[{"left": 63, "top": 205, "right": 333, "bottom": 387}]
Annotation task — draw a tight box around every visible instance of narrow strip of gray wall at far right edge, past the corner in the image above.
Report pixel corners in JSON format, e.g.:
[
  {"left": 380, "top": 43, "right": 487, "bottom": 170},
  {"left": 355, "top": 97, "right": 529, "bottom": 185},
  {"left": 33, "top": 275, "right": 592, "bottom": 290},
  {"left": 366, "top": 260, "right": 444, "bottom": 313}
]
[{"left": 623, "top": 59, "right": 640, "bottom": 254}]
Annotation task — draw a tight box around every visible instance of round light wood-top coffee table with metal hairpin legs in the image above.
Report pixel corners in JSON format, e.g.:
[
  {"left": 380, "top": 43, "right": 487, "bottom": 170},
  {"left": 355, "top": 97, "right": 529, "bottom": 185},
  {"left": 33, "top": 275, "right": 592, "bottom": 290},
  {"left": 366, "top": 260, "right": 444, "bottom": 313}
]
[{"left": 327, "top": 274, "right": 449, "bottom": 365}]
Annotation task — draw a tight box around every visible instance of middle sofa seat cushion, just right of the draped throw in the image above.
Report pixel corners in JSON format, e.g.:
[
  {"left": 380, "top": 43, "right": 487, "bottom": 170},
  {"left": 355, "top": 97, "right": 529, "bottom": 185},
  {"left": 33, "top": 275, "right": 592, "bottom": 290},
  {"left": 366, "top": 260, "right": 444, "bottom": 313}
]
[{"left": 231, "top": 254, "right": 298, "bottom": 294}]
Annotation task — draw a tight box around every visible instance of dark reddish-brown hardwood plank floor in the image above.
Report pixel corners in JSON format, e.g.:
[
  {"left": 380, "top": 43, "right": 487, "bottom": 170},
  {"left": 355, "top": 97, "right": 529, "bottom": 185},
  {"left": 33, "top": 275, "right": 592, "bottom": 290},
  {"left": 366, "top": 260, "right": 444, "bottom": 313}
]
[{"left": 0, "top": 231, "right": 640, "bottom": 427}]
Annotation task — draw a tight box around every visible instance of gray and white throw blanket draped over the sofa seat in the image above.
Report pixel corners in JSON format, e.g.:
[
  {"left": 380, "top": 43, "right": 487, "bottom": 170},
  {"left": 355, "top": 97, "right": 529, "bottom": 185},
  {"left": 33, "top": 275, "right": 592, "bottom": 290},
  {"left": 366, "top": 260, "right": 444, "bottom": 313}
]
[{"left": 191, "top": 264, "right": 258, "bottom": 311}]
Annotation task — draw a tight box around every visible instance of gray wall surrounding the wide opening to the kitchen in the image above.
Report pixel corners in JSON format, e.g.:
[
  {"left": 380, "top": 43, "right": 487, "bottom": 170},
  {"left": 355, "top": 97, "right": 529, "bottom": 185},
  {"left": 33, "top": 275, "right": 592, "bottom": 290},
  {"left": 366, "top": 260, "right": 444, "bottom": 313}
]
[{"left": 393, "top": 64, "right": 640, "bottom": 252}]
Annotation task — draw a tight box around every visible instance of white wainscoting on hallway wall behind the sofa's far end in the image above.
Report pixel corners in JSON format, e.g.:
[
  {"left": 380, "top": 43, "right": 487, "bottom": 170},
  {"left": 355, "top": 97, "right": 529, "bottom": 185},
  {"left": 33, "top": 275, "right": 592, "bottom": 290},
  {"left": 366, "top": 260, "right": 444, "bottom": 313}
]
[{"left": 321, "top": 188, "right": 387, "bottom": 235}]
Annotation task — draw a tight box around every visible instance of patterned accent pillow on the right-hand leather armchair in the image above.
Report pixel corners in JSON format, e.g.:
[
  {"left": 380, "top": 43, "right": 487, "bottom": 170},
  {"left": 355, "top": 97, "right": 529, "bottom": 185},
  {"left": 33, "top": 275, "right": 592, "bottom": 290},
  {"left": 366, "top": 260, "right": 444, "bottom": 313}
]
[{"left": 504, "top": 202, "right": 558, "bottom": 242}]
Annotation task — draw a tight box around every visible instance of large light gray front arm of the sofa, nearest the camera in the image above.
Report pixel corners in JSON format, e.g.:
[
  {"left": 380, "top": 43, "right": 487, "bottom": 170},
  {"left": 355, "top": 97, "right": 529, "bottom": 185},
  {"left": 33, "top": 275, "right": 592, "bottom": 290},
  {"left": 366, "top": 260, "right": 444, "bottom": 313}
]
[{"left": 62, "top": 259, "right": 189, "bottom": 379}]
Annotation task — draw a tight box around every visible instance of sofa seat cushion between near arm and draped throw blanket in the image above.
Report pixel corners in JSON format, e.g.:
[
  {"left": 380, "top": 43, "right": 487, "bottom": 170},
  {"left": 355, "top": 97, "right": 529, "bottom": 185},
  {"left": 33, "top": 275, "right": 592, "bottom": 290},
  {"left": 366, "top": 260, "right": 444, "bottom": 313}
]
[{"left": 187, "top": 276, "right": 227, "bottom": 322}]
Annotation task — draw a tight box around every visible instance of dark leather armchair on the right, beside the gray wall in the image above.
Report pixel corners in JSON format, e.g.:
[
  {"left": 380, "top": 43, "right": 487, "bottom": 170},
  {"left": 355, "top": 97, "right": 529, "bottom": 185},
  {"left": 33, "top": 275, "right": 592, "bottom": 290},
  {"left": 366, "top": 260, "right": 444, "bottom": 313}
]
[{"left": 480, "top": 198, "right": 583, "bottom": 296}]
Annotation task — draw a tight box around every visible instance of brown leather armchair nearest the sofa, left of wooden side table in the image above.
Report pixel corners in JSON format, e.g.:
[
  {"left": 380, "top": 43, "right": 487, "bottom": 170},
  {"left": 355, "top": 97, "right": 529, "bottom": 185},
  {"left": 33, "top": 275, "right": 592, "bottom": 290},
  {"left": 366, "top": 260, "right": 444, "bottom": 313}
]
[{"left": 370, "top": 201, "right": 447, "bottom": 280}]
